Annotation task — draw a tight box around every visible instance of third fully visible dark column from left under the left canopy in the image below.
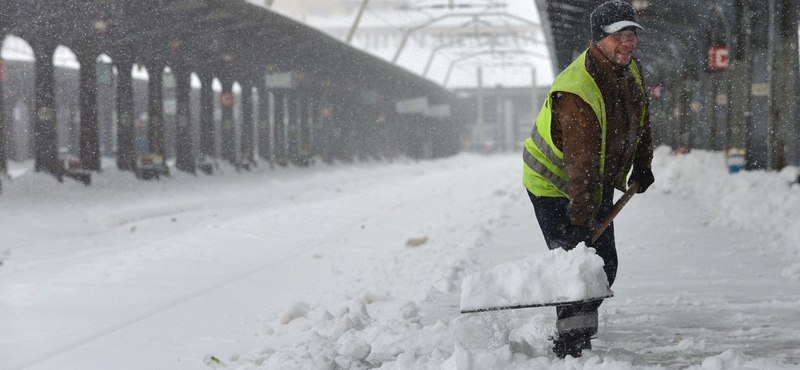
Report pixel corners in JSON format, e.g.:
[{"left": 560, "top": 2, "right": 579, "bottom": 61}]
[{"left": 116, "top": 58, "right": 136, "bottom": 171}]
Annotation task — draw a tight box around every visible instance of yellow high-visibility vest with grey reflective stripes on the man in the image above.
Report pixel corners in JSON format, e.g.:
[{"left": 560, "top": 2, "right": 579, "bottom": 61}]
[{"left": 522, "top": 50, "right": 646, "bottom": 202}]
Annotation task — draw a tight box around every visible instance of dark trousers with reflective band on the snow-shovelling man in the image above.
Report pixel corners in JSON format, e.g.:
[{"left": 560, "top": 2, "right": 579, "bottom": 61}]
[{"left": 528, "top": 186, "right": 617, "bottom": 336}]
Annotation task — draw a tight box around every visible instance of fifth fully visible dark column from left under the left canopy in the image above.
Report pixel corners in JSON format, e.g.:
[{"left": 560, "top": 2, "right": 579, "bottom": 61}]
[{"left": 173, "top": 68, "right": 196, "bottom": 174}]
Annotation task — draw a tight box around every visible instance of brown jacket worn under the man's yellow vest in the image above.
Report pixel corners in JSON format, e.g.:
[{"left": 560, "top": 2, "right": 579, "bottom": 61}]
[{"left": 551, "top": 45, "right": 653, "bottom": 226}]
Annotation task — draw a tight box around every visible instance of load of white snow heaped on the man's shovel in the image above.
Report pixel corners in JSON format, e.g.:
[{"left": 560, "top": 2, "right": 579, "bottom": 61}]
[{"left": 461, "top": 243, "right": 613, "bottom": 311}]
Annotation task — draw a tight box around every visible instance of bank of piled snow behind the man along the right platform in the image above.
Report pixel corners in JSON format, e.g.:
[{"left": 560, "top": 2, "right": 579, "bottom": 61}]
[{"left": 653, "top": 146, "right": 800, "bottom": 268}]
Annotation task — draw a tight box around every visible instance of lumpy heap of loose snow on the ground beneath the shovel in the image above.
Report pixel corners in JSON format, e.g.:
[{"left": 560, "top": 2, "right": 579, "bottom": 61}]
[{"left": 238, "top": 299, "right": 680, "bottom": 370}]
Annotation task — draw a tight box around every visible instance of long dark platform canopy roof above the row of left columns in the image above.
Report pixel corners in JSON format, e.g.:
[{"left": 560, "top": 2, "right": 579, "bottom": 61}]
[{"left": 0, "top": 0, "right": 451, "bottom": 101}]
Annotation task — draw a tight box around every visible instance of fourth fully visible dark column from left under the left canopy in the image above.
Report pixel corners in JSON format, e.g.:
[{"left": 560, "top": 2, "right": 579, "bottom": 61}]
[{"left": 147, "top": 63, "right": 167, "bottom": 159}]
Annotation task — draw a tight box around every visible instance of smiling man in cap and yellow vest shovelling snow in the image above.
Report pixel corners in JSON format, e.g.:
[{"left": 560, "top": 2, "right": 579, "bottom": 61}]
[{"left": 523, "top": 1, "right": 655, "bottom": 358}]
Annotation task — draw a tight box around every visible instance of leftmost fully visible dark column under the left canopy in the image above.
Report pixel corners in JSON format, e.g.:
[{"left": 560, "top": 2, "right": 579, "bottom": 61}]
[{"left": 31, "top": 44, "right": 62, "bottom": 179}]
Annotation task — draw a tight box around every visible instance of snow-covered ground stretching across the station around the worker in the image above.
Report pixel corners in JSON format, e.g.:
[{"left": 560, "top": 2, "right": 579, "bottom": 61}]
[{"left": 0, "top": 148, "right": 800, "bottom": 370}]
